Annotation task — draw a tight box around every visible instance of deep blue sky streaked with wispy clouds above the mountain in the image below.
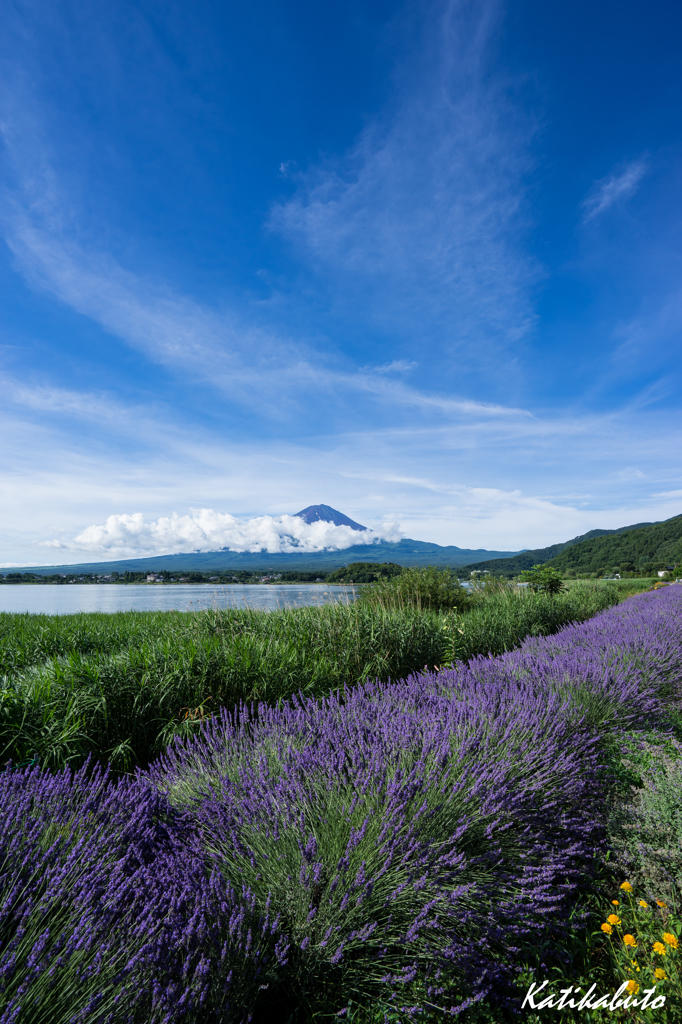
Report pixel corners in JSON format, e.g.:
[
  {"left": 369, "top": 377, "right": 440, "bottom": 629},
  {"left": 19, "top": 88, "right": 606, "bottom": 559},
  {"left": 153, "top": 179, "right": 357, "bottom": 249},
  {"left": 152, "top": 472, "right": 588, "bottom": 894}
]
[{"left": 0, "top": 0, "right": 682, "bottom": 565}]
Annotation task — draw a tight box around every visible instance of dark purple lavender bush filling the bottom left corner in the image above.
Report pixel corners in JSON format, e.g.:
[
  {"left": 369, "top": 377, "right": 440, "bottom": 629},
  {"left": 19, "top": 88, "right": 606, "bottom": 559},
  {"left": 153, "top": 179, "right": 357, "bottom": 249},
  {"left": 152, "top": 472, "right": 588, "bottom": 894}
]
[{"left": 0, "top": 769, "right": 286, "bottom": 1024}]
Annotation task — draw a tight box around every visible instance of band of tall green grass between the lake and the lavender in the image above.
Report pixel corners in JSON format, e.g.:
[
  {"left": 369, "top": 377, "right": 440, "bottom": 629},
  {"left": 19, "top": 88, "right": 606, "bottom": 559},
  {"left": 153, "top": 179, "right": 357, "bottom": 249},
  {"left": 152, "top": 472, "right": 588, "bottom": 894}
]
[{"left": 0, "top": 581, "right": 622, "bottom": 771}]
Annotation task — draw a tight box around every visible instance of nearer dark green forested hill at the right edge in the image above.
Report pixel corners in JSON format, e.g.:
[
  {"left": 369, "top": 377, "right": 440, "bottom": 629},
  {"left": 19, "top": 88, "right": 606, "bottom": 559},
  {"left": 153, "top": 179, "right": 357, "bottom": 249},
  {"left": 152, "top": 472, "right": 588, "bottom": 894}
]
[{"left": 549, "top": 515, "right": 682, "bottom": 572}]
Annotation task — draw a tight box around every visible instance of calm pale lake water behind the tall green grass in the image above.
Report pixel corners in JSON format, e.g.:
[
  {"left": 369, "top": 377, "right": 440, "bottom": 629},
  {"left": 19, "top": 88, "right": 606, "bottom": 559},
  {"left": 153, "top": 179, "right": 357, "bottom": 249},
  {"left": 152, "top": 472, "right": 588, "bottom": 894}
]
[{"left": 0, "top": 584, "right": 355, "bottom": 615}]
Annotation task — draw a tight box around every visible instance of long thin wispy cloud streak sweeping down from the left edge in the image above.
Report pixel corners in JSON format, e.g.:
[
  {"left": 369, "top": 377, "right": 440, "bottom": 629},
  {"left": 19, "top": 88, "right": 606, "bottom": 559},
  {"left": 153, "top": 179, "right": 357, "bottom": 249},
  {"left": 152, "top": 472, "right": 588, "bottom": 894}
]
[{"left": 1, "top": 202, "right": 529, "bottom": 418}]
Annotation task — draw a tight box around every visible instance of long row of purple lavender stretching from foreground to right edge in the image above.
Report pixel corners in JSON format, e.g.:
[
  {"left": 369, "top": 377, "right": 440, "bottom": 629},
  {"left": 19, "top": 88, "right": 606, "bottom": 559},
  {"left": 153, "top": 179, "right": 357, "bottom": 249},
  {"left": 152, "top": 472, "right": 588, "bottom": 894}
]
[{"left": 0, "top": 587, "right": 682, "bottom": 1024}]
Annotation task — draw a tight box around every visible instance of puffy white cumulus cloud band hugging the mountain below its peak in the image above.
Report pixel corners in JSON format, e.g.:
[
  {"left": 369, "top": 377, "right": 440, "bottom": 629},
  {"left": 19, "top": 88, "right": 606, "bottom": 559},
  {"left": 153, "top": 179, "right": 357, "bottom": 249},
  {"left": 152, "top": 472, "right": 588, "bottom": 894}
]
[{"left": 43, "top": 509, "right": 402, "bottom": 557}]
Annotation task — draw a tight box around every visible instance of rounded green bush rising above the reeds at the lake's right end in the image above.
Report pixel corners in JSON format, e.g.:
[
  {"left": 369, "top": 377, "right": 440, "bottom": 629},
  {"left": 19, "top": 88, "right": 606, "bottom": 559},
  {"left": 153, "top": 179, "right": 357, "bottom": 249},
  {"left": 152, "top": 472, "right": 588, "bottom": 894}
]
[{"left": 361, "top": 565, "right": 470, "bottom": 611}]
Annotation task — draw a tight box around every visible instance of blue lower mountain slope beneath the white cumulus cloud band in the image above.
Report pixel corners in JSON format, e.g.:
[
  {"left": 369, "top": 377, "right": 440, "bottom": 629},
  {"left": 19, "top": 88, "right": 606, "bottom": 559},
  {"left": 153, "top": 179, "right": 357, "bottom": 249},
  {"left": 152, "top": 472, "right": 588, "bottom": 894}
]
[{"left": 0, "top": 540, "right": 515, "bottom": 575}]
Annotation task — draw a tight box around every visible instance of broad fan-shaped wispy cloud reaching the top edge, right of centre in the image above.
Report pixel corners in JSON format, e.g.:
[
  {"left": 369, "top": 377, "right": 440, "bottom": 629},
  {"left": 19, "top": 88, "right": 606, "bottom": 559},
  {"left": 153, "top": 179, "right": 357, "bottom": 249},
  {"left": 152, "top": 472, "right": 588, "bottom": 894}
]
[{"left": 271, "top": 0, "right": 538, "bottom": 362}]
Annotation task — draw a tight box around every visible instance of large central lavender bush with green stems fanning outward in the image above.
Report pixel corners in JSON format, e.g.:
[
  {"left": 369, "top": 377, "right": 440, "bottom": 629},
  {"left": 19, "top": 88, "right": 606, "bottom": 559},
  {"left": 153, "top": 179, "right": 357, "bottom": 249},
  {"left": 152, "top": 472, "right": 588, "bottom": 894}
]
[{"left": 151, "top": 678, "right": 602, "bottom": 1011}]
